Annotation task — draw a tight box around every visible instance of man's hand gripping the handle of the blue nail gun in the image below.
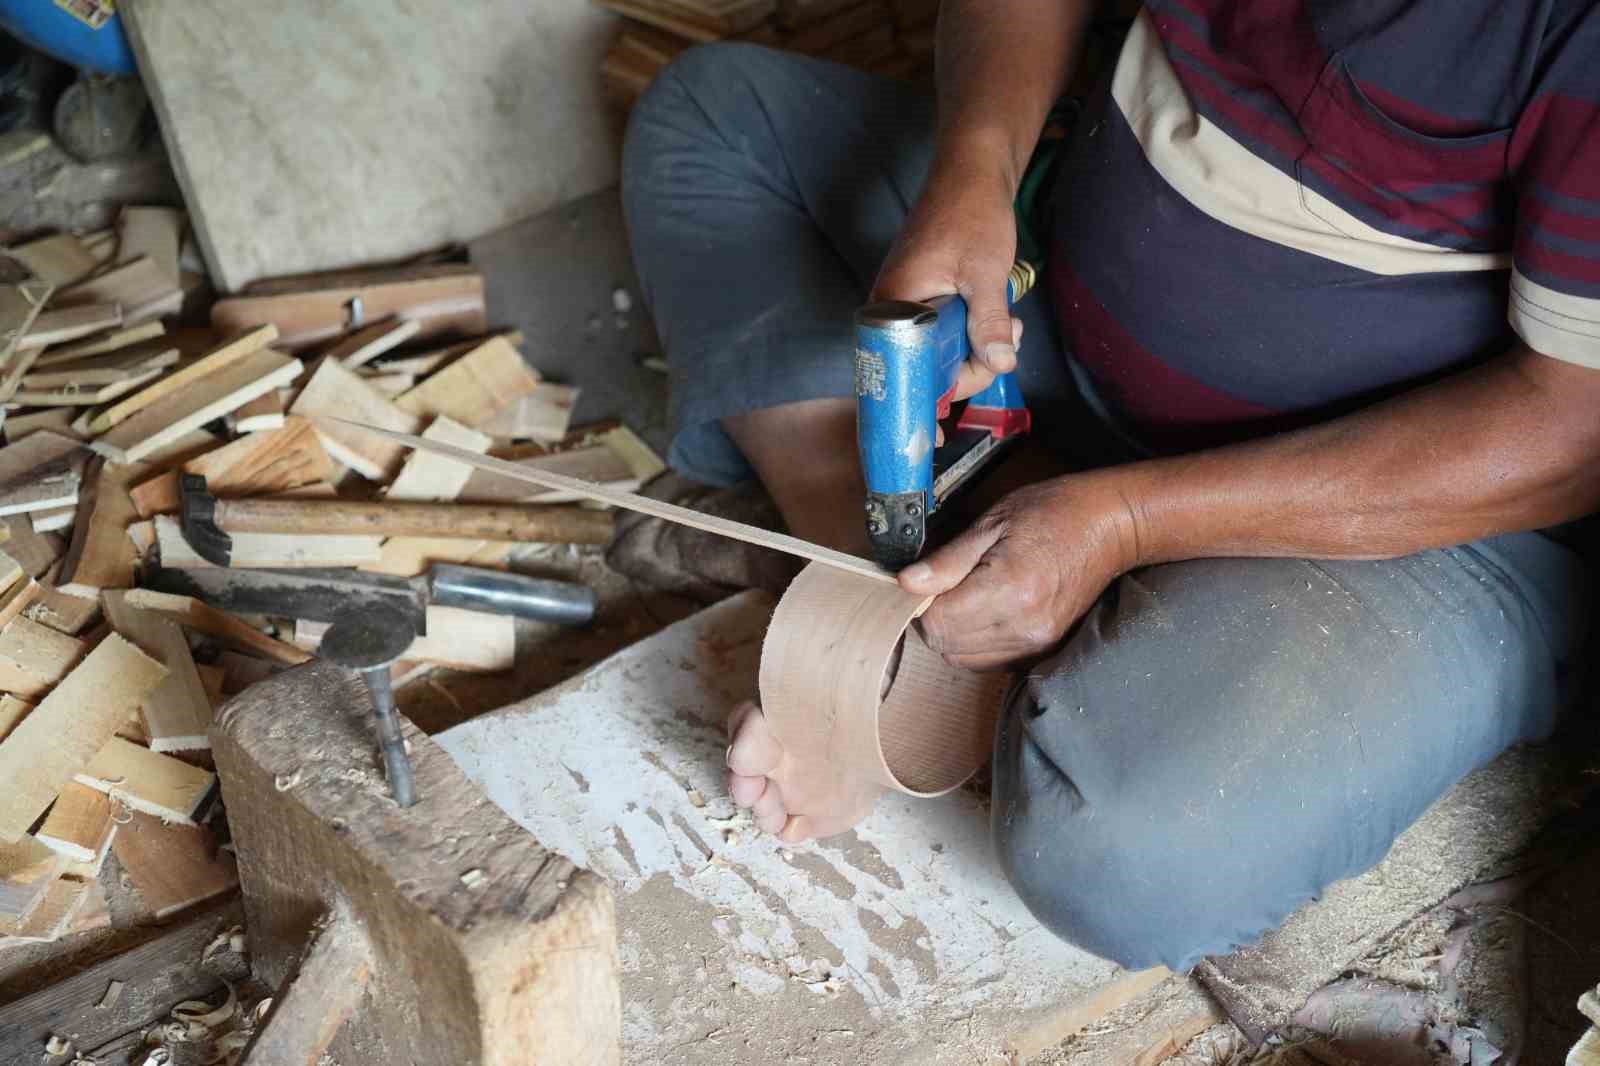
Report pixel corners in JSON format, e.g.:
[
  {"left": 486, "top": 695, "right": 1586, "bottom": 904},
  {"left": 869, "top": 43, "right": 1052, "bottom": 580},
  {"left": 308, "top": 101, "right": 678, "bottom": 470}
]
[{"left": 872, "top": 147, "right": 1022, "bottom": 400}]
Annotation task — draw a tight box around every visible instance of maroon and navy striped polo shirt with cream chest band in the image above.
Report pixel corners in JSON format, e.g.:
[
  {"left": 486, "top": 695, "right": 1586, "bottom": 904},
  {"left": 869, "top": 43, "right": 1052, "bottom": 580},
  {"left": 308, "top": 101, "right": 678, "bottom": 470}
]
[{"left": 1050, "top": 0, "right": 1600, "bottom": 448}]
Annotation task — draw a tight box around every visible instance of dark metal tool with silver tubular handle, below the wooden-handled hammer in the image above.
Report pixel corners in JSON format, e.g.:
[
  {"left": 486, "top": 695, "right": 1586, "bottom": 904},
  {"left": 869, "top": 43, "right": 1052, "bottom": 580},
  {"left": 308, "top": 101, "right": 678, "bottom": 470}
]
[{"left": 142, "top": 563, "right": 595, "bottom": 635}]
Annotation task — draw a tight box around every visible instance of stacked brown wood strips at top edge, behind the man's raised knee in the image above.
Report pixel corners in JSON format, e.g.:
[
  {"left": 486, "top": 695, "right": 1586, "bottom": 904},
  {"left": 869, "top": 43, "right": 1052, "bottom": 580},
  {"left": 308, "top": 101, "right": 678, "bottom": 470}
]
[{"left": 597, "top": 0, "right": 939, "bottom": 107}]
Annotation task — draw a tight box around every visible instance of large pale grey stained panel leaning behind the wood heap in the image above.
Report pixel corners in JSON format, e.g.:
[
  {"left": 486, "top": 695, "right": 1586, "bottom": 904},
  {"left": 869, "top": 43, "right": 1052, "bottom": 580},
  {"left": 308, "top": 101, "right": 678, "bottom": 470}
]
[{"left": 118, "top": 0, "right": 616, "bottom": 291}]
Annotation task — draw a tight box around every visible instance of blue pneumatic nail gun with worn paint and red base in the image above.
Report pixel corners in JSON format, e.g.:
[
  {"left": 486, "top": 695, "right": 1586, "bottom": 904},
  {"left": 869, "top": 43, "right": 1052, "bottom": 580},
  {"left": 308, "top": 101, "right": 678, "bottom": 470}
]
[{"left": 856, "top": 262, "right": 1035, "bottom": 570}]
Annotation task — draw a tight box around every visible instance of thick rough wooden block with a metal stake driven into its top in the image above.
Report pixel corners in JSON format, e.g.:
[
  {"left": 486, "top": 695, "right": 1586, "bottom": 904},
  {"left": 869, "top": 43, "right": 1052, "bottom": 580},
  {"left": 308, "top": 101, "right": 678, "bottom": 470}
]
[{"left": 222, "top": 663, "right": 621, "bottom": 1066}]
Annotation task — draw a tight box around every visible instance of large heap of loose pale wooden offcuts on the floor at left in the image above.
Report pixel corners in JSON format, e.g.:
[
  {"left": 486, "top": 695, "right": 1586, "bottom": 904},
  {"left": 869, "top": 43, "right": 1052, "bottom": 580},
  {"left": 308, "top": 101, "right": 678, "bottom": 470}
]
[{"left": 0, "top": 208, "right": 662, "bottom": 951}]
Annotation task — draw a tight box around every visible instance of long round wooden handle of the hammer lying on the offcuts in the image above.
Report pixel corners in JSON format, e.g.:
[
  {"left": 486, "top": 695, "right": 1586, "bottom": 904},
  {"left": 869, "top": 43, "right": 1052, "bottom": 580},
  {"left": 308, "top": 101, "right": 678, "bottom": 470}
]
[{"left": 216, "top": 499, "right": 613, "bottom": 544}]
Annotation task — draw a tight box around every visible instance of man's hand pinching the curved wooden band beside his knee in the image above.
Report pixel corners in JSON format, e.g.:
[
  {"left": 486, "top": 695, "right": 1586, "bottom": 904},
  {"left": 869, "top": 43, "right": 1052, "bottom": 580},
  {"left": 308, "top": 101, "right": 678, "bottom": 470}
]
[{"left": 899, "top": 471, "right": 1139, "bottom": 669}]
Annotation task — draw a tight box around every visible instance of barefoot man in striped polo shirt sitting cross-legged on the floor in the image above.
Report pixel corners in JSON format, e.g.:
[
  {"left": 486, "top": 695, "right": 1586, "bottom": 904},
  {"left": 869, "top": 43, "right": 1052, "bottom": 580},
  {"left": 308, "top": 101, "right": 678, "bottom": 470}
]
[{"left": 624, "top": 0, "right": 1600, "bottom": 968}]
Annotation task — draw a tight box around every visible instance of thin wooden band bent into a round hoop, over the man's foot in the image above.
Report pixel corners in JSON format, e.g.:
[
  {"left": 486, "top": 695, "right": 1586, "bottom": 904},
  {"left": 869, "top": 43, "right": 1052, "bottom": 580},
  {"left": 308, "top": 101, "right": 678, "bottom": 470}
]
[{"left": 760, "top": 563, "right": 1006, "bottom": 795}]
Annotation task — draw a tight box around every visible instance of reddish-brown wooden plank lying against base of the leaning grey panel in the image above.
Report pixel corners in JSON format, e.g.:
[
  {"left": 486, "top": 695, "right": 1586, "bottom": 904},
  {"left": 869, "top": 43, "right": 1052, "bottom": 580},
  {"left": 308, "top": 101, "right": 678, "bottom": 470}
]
[{"left": 211, "top": 266, "right": 488, "bottom": 352}]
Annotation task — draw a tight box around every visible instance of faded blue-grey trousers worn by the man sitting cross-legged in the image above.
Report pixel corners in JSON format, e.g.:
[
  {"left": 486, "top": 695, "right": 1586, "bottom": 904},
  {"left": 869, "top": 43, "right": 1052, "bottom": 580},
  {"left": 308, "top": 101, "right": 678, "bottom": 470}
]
[{"left": 622, "top": 43, "right": 1589, "bottom": 970}]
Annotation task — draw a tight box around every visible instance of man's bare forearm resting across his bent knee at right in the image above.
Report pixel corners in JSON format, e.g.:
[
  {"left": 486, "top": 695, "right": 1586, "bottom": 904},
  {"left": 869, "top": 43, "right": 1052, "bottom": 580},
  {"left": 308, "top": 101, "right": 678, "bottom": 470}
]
[{"left": 1113, "top": 349, "right": 1600, "bottom": 565}]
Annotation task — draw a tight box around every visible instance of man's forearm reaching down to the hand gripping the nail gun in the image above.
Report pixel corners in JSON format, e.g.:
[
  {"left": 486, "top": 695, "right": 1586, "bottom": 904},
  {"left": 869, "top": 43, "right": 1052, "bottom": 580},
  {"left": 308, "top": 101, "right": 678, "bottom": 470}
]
[{"left": 934, "top": 0, "right": 1098, "bottom": 194}]
